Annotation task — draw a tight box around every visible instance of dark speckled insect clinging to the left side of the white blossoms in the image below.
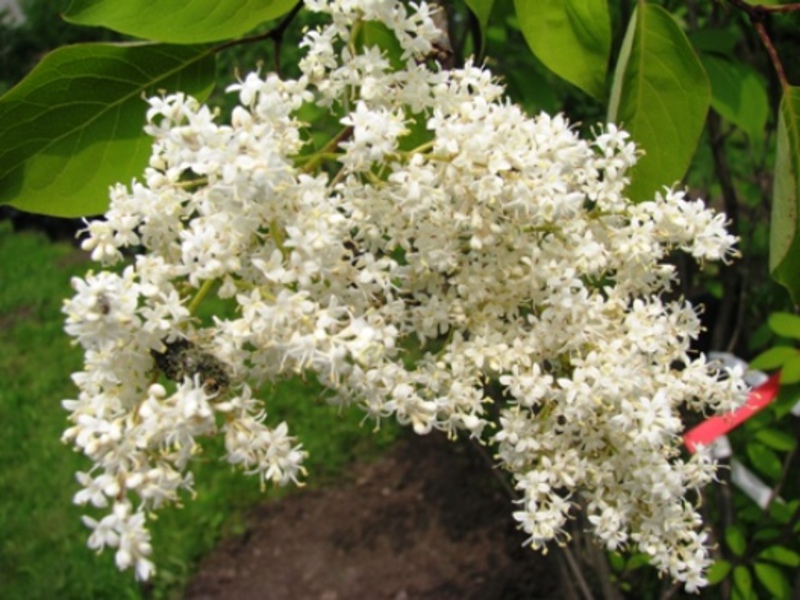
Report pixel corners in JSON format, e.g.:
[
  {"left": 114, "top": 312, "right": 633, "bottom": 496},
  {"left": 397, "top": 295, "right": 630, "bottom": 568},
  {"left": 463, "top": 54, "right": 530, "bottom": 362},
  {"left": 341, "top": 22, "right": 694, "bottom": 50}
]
[{"left": 150, "top": 338, "right": 231, "bottom": 394}]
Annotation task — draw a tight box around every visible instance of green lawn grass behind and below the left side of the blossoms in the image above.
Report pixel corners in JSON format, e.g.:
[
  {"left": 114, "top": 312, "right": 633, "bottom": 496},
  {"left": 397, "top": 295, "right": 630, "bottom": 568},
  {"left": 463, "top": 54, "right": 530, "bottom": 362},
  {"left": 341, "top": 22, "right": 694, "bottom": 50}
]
[{"left": 0, "top": 223, "right": 397, "bottom": 600}]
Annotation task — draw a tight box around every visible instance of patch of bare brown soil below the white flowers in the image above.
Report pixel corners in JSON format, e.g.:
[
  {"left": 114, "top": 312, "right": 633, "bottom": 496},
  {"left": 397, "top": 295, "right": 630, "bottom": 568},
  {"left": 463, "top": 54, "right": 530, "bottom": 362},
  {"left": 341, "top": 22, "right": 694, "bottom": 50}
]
[{"left": 186, "top": 435, "right": 561, "bottom": 600}]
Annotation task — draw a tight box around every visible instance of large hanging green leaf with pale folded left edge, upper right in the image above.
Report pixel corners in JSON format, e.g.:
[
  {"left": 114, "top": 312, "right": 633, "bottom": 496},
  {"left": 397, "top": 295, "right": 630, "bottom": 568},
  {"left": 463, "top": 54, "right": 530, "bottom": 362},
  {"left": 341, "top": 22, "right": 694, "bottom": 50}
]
[{"left": 608, "top": 3, "right": 711, "bottom": 201}]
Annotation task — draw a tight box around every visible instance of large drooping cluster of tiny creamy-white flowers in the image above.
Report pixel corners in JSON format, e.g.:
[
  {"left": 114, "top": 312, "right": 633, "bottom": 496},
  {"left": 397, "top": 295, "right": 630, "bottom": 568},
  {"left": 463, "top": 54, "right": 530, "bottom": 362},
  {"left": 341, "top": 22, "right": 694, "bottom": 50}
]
[{"left": 64, "top": 0, "right": 743, "bottom": 589}]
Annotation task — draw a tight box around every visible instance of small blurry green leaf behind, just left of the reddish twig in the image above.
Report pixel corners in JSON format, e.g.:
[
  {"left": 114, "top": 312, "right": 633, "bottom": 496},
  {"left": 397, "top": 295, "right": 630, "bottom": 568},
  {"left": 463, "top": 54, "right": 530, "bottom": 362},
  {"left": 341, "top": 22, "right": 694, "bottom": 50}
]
[{"left": 700, "top": 54, "right": 769, "bottom": 141}]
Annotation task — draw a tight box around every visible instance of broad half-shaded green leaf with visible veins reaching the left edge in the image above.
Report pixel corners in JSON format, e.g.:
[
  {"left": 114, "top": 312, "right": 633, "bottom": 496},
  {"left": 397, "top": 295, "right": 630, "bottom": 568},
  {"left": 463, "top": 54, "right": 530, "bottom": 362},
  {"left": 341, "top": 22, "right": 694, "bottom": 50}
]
[{"left": 0, "top": 44, "right": 215, "bottom": 217}]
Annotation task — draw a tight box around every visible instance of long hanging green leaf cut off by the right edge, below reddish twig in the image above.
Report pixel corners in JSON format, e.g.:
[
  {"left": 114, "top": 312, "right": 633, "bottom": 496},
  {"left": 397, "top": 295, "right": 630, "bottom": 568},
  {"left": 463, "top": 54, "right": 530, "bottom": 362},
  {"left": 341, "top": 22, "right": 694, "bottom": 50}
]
[{"left": 769, "top": 87, "right": 800, "bottom": 304}]
